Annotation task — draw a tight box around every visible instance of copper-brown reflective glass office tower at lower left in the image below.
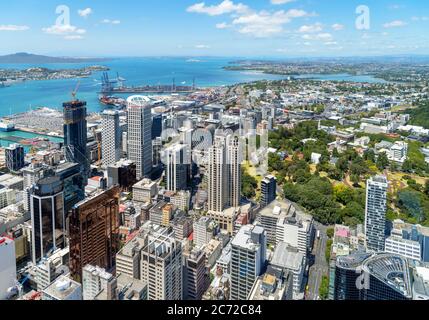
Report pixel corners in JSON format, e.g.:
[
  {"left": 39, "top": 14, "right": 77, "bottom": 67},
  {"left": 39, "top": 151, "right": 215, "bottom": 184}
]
[{"left": 69, "top": 187, "right": 119, "bottom": 282}]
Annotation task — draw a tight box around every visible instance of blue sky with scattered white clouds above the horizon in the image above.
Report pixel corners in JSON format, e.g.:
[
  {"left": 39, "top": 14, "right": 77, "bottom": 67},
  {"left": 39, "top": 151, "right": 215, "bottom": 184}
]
[{"left": 0, "top": 0, "right": 429, "bottom": 57}]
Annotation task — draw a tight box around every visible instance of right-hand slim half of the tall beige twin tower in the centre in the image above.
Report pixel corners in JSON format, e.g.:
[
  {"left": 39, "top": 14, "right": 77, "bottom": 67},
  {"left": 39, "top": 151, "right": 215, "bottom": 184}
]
[{"left": 227, "top": 136, "right": 242, "bottom": 207}]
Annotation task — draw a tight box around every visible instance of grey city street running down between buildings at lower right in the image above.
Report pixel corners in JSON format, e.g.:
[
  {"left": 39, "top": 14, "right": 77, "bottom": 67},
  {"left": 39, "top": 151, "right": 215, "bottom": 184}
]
[{"left": 306, "top": 223, "right": 329, "bottom": 300}]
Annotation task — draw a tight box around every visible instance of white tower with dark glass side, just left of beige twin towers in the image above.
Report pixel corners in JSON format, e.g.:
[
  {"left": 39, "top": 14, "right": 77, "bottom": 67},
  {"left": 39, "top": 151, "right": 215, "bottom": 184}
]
[{"left": 164, "top": 144, "right": 191, "bottom": 192}]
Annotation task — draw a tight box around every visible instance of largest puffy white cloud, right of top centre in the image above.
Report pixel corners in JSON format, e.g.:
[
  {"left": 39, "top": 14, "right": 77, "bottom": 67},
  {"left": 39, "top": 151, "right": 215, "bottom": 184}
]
[{"left": 232, "top": 9, "right": 311, "bottom": 37}]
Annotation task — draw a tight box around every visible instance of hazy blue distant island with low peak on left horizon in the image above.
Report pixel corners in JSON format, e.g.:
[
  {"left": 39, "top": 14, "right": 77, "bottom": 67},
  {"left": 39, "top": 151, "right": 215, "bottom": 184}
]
[{"left": 0, "top": 52, "right": 107, "bottom": 64}]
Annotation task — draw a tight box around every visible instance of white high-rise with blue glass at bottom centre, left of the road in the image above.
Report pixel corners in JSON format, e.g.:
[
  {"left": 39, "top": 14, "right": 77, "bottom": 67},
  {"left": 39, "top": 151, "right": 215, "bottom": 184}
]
[{"left": 231, "top": 225, "right": 267, "bottom": 300}]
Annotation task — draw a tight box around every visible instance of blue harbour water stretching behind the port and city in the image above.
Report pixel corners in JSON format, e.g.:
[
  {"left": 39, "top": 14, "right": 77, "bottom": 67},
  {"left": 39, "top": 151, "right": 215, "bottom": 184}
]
[{"left": 0, "top": 57, "right": 381, "bottom": 117}]
